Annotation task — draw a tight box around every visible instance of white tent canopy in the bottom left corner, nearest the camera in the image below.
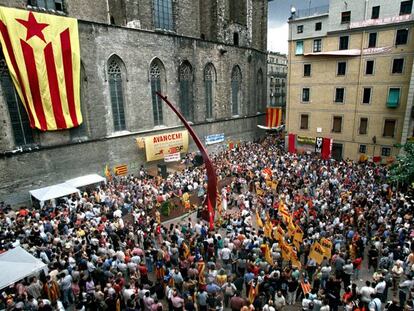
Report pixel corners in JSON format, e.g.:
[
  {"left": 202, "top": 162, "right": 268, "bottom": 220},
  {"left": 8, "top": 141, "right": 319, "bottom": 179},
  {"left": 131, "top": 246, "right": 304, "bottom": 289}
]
[{"left": 0, "top": 246, "right": 47, "bottom": 289}]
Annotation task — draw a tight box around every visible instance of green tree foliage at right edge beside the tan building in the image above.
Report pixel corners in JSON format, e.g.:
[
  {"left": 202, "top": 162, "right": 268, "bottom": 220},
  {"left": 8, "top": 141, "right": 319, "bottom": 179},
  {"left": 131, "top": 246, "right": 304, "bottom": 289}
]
[{"left": 389, "top": 142, "right": 414, "bottom": 185}]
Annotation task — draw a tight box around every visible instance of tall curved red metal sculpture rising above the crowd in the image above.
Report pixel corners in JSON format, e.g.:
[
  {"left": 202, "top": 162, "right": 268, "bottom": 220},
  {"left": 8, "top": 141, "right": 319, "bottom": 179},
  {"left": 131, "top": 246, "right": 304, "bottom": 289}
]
[{"left": 156, "top": 92, "right": 217, "bottom": 230}]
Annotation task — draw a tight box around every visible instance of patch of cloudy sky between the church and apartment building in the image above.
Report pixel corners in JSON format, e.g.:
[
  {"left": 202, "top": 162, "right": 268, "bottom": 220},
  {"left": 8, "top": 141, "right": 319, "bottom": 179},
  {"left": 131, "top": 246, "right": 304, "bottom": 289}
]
[{"left": 267, "top": 0, "right": 329, "bottom": 54}]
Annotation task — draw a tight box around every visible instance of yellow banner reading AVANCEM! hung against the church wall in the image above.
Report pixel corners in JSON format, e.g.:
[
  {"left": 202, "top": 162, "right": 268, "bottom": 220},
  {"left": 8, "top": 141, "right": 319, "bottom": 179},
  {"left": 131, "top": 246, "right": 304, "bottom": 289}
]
[{"left": 145, "top": 131, "right": 188, "bottom": 161}]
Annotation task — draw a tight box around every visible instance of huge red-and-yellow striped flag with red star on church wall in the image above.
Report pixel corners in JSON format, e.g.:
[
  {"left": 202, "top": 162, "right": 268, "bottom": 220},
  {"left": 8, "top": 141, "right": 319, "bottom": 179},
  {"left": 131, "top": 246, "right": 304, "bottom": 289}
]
[{"left": 0, "top": 7, "right": 82, "bottom": 131}]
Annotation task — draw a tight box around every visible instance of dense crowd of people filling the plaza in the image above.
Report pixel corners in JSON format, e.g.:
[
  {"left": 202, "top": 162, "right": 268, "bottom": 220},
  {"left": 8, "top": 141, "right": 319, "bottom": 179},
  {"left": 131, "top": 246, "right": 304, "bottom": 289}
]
[{"left": 0, "top": 136, "right": 414, "bottom": 311}]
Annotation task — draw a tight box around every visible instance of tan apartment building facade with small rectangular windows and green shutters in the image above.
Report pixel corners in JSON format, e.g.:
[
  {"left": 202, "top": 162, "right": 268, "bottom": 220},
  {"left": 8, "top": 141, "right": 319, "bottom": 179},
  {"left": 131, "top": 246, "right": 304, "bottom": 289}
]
[{"left": 287, "top": 0, "right": 414, "bottom": 162}]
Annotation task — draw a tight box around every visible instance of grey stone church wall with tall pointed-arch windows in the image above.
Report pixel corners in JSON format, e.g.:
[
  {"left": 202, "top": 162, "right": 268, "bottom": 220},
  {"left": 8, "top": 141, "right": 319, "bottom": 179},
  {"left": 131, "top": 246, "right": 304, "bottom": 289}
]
[{"left": 0, "top": 0, "right": 267, "bottom": 205}]
